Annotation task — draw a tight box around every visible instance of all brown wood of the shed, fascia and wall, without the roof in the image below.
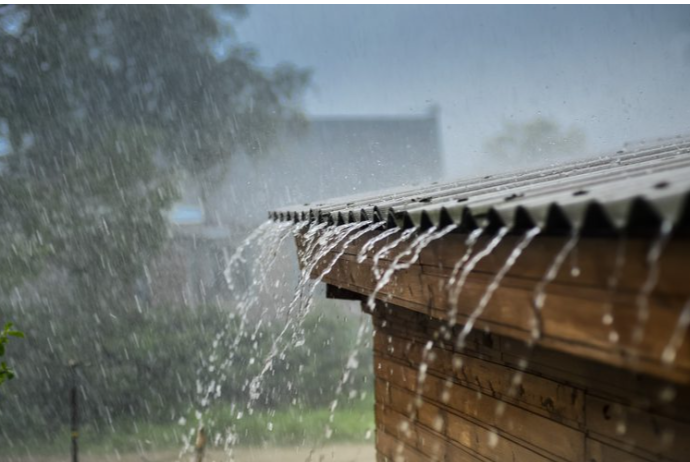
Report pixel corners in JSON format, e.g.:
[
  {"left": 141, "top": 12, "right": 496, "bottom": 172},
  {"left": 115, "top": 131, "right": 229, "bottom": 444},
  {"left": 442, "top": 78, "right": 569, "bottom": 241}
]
[{"left": 298, "top": 229, "right": 690, "bottom": 462}]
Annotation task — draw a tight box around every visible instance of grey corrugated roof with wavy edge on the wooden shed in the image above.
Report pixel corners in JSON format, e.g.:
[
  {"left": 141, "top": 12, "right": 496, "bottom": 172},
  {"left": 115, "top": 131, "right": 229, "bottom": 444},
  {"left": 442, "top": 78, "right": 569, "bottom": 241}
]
[{"left": 269, "top": 138, "right": 690, "bottom": 234}]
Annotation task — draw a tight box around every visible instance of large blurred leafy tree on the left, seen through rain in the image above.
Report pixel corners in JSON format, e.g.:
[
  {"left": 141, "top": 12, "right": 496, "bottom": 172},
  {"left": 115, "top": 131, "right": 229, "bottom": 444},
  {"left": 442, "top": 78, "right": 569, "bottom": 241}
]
[{"left": 0, "top": 4, "right": 308, "bottom": 434}]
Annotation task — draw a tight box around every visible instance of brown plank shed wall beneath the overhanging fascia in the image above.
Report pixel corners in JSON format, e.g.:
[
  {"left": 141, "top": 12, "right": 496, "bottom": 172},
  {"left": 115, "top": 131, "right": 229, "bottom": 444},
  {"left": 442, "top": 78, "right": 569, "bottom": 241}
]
[{"left": 372, "top": 303, "right": 690, "bottom": 462}]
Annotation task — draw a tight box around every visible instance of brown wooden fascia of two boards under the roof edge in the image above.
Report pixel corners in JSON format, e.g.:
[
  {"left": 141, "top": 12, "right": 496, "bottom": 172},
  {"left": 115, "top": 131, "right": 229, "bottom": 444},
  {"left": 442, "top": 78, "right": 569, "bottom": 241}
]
[{"left": 297, "top": 229, "right": 690, "bottom": 384}]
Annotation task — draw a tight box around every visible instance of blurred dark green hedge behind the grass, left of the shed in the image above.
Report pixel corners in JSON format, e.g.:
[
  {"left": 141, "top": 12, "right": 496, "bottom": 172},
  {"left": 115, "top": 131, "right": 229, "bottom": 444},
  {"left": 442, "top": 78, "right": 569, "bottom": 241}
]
[{"left": 0, "top": 301, "right": 373, "bottom": 445}]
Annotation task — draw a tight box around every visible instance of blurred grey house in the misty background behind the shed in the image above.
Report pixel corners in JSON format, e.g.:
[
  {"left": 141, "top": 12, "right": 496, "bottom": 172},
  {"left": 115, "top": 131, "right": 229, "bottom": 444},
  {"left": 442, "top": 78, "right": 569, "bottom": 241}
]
[{"left": 149, "top": 107, "right": 443, "bottom": 305}]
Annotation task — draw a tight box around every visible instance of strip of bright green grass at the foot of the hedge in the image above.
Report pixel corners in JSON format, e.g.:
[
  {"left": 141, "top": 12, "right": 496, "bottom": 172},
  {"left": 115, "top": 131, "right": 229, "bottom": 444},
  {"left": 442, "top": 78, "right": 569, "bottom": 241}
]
[{"left": 3, "top": 399, "right": 374, "bottom": 455}]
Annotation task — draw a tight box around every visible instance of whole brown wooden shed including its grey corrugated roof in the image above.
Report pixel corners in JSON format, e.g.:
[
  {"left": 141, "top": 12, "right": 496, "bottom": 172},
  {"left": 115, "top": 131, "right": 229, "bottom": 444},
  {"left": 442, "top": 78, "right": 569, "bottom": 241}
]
[{"left": 271, "top": 139, "right": 690, "bottom": 462}]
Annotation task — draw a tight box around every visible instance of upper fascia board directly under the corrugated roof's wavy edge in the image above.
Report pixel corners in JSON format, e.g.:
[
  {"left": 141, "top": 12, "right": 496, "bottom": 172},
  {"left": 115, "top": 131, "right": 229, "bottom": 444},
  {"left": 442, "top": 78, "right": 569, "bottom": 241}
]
[{"left": 322, "top": 232, "right": 690, "bottom": 296}]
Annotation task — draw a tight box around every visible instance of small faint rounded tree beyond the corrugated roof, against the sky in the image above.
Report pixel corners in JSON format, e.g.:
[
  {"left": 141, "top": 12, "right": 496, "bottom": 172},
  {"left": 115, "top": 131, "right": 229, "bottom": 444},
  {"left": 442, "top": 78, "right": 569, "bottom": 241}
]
[{"left": 484, "top": 117, "right": 585, "bottom": 161}]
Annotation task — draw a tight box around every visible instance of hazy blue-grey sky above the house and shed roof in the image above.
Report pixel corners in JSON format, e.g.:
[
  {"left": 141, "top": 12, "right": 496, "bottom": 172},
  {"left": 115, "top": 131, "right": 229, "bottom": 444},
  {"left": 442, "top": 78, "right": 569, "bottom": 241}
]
[{"left": 237, "top": 5, "right": 690, "bottom": 177}]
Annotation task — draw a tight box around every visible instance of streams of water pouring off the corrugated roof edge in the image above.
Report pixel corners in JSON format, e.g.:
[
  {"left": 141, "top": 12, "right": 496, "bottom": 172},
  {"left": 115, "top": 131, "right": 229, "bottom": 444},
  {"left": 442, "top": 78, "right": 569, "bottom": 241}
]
[{"left": 176, "top": 181, "right": 690, "bottom": 458}]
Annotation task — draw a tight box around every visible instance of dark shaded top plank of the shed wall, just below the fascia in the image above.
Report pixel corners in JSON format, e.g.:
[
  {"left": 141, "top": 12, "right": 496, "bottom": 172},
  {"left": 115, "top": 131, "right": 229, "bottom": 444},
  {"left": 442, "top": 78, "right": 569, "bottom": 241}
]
[{"left": 373, "top": 306, "right": 690, "bottom": 423}]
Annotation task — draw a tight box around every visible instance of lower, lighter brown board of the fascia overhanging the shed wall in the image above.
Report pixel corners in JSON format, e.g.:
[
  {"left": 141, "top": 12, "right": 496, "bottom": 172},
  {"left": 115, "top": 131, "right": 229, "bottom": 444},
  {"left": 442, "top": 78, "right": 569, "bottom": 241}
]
[{"left": 326, "top": 260, "right": 690, "bottom": 383}]
